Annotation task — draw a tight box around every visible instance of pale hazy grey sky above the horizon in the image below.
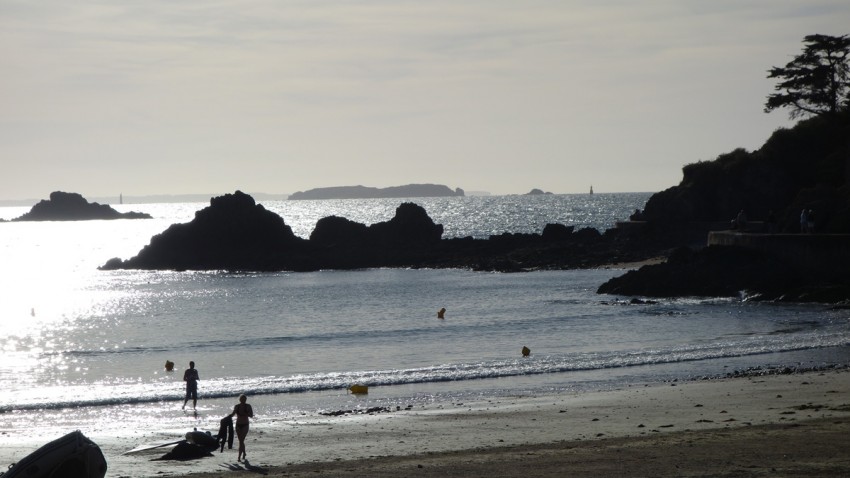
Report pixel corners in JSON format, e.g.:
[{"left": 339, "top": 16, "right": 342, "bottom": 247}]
[{"left": 0, "top": 0, "right": 850, "bottom": 199}]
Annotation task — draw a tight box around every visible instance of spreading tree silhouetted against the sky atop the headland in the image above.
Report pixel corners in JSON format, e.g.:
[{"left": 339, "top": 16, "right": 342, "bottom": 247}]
[{"left": 764, "top": 35, "right": 850, "bottom": 118}]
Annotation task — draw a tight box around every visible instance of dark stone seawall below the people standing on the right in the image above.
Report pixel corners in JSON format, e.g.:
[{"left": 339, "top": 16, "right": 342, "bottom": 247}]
[{"left": 708, "top": 231, "right": 850, "bottom": 271}]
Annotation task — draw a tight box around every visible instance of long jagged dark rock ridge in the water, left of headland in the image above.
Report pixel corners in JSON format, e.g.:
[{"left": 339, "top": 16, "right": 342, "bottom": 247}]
[{"left": 101, "top": 191, "right": 657, "bottom": 271}]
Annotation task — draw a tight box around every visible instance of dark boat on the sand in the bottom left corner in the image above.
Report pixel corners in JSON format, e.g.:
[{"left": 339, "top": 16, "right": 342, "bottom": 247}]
[{"left": 0, "top": 430, "right": 106, "bottom": 478}]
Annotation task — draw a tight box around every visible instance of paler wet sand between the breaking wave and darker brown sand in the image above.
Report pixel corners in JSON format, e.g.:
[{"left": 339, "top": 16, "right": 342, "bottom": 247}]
[{"left": 0, "top": 369, "right": 850, "bottom": 477}]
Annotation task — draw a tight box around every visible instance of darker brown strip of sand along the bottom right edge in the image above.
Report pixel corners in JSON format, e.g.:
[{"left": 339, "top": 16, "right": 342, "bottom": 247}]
[{"left": 245, "top": 418, "right": 850, "bottom": 478}]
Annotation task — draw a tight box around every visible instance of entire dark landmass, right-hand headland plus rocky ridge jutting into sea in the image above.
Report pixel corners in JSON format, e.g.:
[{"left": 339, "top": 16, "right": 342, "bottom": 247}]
[{"left": 96, "top": 109, "right": 850, "bottom": 302}]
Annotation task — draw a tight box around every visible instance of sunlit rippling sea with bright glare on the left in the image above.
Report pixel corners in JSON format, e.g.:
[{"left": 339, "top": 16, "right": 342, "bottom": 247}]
[{"left": 0, "top": 193, "right": 850, "bottom": 442}]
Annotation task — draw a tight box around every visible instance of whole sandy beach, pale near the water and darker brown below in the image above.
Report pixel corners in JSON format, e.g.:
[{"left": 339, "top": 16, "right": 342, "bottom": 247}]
[{"left": 0, "top": 369, "right": 850, "bottom": 478}]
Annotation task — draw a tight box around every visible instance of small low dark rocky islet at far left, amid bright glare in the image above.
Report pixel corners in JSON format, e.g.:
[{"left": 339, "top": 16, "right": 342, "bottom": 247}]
[{"left": 12, "top": 191, "right": 151, "bottom": 221}]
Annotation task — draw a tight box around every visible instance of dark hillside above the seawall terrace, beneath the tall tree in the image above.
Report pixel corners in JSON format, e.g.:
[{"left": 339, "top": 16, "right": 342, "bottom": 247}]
[{"left": 641, "top": 112, "right": 850, "bottom": 233}]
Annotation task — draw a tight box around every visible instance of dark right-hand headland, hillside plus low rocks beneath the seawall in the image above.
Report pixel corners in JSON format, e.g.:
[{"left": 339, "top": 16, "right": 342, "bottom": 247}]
[{"left": 598, "top": 111, "right": 850, "bottom": 303}]
